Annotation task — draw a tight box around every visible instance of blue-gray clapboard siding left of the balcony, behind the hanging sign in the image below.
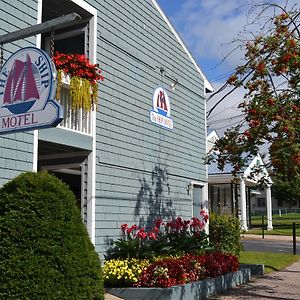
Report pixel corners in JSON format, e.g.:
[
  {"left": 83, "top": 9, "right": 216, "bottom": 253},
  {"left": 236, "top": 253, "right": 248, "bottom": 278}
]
[{"left": 0, "top": 0, "right": 37, "bottom": 186}]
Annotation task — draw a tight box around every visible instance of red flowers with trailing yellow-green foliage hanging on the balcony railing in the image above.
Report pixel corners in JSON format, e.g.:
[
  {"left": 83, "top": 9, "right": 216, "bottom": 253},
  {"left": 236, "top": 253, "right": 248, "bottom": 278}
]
[{"left": 52, "top": 52, "right": 104, "bottom": 110}]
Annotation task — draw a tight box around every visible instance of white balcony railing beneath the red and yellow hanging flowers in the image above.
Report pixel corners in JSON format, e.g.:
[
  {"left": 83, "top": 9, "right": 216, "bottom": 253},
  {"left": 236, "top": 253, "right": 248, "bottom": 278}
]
[{"left": 59, "top": 76, "right": 93, "bottom": 134}]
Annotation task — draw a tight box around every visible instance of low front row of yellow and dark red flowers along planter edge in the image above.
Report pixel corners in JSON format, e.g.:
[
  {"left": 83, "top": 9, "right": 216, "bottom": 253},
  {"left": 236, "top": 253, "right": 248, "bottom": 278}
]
[{"left": 103, "top": 252, "right": 239, "bottom": 288}]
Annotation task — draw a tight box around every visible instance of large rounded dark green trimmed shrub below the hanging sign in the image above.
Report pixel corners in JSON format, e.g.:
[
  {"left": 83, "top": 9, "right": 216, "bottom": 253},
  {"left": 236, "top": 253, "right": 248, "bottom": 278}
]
[{"left": 0, "top": 172, "right": 104, "bottom": 300}]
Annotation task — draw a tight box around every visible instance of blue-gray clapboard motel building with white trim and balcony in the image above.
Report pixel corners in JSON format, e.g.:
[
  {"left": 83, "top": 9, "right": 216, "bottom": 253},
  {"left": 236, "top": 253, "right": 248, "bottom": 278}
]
[{"left": 0, "top": 0, "right": 212, "bottom": 252}]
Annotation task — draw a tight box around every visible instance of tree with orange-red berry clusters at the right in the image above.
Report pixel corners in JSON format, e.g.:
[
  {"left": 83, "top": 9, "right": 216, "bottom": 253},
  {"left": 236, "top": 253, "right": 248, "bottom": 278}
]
[{"left": 209, "top": 3, "right": 300, "bottom": 200}]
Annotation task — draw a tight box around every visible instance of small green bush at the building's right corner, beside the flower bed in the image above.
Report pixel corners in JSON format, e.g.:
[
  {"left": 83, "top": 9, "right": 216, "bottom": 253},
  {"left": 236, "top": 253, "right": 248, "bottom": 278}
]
[{"left": 209, "top": 214, "right": 243, "bottom": 256}]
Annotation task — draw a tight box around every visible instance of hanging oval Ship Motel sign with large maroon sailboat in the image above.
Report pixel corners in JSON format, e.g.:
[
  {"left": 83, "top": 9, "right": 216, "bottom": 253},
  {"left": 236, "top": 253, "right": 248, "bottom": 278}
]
[{"left": 0, "top": 47, "right": 63, "bottom": 134}]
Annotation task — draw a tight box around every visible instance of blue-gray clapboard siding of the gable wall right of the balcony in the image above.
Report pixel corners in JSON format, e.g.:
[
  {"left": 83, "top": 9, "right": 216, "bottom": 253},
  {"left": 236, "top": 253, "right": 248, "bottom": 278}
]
[{"left": 90, "top": 0, "right": 206, "bottom": 252}]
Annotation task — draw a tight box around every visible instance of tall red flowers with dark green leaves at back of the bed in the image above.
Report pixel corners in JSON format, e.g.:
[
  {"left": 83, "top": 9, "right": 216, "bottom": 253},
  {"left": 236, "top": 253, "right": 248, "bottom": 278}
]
[{"left": 106, "top": 211, "right": 209, "bottom": 259}]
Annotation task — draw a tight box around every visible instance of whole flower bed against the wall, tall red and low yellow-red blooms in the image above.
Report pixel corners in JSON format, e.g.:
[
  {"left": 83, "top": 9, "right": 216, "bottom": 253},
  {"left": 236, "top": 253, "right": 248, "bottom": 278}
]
[{"left": 103, "top": 212, "right": 249, "bottom": 299}]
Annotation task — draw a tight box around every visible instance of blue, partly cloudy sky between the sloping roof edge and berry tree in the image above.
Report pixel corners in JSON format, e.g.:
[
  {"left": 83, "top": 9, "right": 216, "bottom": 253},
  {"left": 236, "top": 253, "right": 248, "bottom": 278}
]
[{"left": 157, "top": 0, "right": 299, "bottom": 135}]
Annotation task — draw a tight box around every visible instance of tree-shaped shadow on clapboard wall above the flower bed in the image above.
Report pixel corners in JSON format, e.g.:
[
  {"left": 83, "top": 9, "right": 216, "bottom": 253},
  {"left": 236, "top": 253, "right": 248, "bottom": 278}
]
[{"left": 134, "top": 164, "right": 175, "bottom": 228}]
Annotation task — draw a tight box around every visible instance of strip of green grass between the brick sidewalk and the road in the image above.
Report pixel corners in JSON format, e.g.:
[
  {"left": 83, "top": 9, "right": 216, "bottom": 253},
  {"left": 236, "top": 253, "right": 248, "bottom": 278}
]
[{"left": 240, "top": 251, "right": 300, "bottom": 273}]
